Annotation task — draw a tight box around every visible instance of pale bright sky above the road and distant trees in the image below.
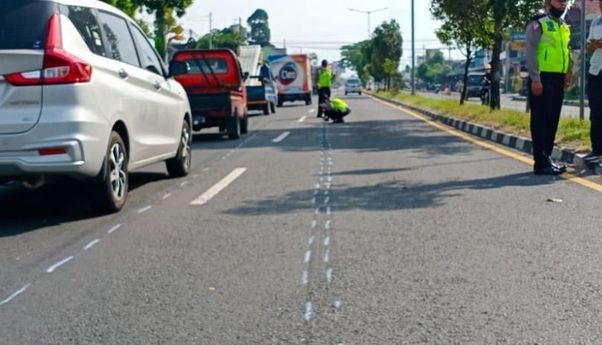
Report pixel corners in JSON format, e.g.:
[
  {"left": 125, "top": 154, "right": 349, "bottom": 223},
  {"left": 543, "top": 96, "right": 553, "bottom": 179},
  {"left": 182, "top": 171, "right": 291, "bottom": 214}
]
[{"left": 181, "top": 0, "right": 458, "bottom": 66}]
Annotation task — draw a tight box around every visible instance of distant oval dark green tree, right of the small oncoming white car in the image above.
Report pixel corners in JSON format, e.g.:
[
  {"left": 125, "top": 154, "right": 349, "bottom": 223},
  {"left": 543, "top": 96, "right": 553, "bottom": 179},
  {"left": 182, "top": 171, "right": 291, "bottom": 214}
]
[{"left": 369, "top": 19, "right": 403, "bottom": 86}]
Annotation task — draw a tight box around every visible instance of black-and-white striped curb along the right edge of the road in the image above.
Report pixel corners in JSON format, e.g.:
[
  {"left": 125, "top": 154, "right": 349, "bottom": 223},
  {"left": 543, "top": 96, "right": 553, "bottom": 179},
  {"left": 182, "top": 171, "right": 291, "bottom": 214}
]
[{"left": 368, "top": 92, "right": 602, "bottom": 175}]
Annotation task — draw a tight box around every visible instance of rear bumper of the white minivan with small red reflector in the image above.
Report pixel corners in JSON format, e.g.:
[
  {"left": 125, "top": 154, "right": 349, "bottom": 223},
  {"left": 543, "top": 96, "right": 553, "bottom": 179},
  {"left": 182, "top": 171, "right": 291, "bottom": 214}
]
[{"left": 0, "top": 108, "right": 110, "bottom": 179}]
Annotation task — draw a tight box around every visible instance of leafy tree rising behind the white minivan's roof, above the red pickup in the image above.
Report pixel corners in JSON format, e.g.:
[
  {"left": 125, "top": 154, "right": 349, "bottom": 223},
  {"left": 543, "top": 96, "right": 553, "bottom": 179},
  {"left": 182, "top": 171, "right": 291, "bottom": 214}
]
[{"left": 135, "top": 0, "right": 194, "bottom": 59}]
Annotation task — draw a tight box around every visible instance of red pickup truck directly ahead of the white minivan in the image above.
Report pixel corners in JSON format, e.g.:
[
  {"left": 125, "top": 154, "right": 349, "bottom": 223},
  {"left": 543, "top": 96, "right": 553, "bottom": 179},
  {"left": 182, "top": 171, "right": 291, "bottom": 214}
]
[{"left": 169, "top": 49, "right": 249, "bottom": 139}]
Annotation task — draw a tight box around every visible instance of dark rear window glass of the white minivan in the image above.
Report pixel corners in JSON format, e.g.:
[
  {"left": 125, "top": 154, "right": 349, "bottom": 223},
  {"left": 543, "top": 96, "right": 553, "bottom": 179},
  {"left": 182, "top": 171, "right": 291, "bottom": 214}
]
[{"left": 0, "top": 0, "right": 57, "bottom": 50}]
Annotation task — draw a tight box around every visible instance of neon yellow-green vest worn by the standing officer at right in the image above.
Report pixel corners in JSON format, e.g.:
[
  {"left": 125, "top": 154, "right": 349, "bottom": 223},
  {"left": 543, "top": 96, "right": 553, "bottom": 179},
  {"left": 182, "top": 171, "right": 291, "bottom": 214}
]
[{"left": 537, "top": 16, "right": 571, "bottom": 73}]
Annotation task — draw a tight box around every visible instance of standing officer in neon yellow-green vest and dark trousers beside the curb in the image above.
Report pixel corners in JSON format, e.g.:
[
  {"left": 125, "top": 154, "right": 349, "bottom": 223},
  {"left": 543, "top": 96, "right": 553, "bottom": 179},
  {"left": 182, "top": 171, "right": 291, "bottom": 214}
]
[{"left": 526, "top": 0, "right": 572, "bottom": 175}]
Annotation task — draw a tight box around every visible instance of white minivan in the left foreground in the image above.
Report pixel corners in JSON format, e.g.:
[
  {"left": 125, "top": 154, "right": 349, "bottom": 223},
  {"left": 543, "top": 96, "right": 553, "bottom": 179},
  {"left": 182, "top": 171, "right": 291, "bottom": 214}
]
[{"left": 0, "top": 0, "right": 192, "bottom": 212}]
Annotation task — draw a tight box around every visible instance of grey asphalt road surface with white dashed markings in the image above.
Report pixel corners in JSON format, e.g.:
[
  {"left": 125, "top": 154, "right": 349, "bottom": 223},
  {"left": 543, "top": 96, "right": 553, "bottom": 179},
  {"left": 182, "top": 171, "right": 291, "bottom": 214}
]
[{"left": 0, "top": 92, "right": 602, "bottom": 345}]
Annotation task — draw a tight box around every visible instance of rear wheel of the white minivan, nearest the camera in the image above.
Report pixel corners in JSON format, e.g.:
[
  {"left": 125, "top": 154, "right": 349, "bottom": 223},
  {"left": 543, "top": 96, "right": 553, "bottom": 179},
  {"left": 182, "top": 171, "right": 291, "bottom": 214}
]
[{"left": 95, "top": 131, "right": 129, "bottom": 213}]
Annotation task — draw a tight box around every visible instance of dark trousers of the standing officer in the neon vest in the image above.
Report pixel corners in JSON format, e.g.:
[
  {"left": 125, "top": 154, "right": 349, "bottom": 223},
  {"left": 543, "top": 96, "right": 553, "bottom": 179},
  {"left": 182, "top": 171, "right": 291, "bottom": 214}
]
[{"left": 529, "top": 72, "right": 565, "bottom": 169}]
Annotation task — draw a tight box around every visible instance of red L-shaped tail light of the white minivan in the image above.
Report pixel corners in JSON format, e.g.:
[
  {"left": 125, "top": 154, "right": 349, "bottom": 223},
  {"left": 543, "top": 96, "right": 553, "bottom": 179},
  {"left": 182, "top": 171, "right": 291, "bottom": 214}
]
[{"left": 4, "top": 14, "right": 92, "bottom": 86}]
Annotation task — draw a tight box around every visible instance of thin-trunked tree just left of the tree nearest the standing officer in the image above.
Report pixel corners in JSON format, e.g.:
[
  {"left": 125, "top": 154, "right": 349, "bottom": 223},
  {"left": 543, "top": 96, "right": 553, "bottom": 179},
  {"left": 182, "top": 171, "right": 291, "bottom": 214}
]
[{"left": 431, "top": 0, "right": 493, "bottom": 104}]
